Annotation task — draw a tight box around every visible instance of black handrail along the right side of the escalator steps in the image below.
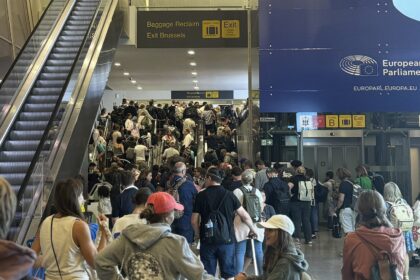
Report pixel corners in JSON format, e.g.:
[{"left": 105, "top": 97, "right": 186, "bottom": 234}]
[{"left": 17, "top": 1, "right": 101, "bottom": 205}]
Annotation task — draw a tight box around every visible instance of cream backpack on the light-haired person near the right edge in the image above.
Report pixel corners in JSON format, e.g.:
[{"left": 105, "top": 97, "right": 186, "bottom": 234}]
[{"left": 387, "top": 199, "right": 414, "bottom": 231}]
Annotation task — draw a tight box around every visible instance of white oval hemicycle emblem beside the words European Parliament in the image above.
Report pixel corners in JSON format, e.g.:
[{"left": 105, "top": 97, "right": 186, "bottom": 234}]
[{"left": 340, "top": 55, "right": 378, "bottom": 76}]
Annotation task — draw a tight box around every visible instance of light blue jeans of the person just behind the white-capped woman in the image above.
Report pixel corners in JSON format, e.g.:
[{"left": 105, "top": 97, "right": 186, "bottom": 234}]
[{"left": 235, "top": 239, "right": 264, "bottom": 275}]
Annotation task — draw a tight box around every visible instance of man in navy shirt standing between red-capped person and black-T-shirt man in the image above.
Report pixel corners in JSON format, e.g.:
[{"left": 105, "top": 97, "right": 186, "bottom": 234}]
[{"left": 170, "top": 162, "right": 197, "bottom": 243}]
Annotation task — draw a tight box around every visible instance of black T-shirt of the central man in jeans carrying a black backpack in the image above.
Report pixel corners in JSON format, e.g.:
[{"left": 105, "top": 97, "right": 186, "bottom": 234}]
[{"left": 193, "top": 186, "right": 241, "bottom": 243}]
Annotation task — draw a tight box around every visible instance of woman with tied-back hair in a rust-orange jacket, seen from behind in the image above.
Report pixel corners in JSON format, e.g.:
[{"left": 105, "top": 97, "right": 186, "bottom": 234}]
[{"left": 341, "top": 191, "right": 406, "bottom": 280}]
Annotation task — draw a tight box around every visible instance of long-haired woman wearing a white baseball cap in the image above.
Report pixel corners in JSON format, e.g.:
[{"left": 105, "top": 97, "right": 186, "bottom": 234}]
[{"left": 235, "top": 215, "right": 311, "bottom": 280}]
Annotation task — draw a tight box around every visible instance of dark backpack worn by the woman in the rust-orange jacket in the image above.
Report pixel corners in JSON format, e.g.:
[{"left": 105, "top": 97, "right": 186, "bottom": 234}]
[{"left": 356, "top": 232, "right": 399, "bottom": 280}]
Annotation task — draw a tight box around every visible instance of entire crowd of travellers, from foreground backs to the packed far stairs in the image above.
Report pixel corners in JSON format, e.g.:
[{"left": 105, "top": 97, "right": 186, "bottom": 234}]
[{"left": 0, "top": 98, "right": 420, "bottom": 280}]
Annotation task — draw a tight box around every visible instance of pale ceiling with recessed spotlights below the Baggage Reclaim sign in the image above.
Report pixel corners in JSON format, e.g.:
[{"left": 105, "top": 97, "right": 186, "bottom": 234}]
[{"left": 108, "top": 45, "right": 258, "bottom": 92}]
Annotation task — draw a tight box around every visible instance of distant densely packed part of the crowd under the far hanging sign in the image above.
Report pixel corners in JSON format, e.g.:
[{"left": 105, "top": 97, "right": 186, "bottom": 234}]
[{"left": 91, "top": 99, "right": 243, "bottom": 171}]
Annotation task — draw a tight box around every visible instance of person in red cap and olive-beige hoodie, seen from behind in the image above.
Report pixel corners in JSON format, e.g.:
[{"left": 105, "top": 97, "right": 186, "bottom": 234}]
[{"left": 95, "top": 192, "right": 217, "bottom": 280}]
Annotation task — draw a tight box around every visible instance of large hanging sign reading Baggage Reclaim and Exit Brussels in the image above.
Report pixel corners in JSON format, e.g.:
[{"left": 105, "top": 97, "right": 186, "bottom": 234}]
[{"left": 137, "top": 10, "right": 248, "bottom": 48}]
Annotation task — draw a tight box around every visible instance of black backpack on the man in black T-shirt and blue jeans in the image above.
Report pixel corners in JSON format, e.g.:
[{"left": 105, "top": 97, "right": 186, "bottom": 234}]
[{"left": 203, "top": 190, "right": 233, "bottom": 245}]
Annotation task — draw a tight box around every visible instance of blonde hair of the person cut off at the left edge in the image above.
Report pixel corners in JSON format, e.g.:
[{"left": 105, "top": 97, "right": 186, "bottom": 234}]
[{"left": 0, "top": 177, "right": 16, "bottom": 239}]
